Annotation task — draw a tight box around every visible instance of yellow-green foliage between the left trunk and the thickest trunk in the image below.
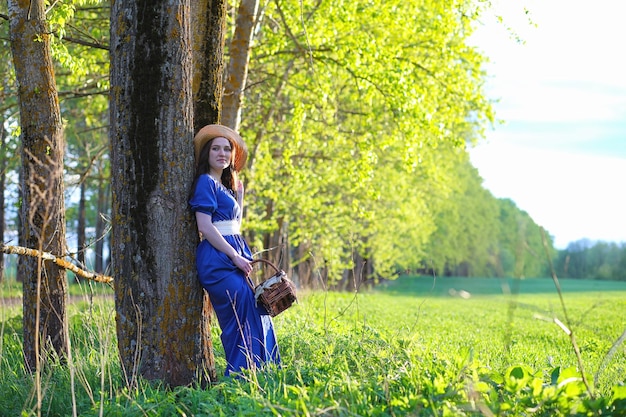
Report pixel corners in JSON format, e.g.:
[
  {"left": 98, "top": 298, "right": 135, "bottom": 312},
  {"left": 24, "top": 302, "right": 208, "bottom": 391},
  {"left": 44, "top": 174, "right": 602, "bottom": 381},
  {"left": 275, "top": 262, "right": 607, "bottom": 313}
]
[{"left": 50, "top": 0, "right": 110, "bottom": 240}]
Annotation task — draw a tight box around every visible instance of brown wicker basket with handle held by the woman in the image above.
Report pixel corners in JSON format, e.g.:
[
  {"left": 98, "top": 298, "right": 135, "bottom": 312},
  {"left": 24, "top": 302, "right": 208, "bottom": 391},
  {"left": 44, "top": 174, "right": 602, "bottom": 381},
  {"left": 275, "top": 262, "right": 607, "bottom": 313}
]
[{"left": 248, "top": 259, "right": 298, "bottom": 317}]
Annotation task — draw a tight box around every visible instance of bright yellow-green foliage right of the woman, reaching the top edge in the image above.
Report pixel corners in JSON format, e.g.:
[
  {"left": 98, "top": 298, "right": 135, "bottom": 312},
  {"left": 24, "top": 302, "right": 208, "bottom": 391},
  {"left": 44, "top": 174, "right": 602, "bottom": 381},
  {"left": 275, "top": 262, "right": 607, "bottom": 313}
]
[{"left": 243, "top": 0, "right": 491, "bottom": 279}]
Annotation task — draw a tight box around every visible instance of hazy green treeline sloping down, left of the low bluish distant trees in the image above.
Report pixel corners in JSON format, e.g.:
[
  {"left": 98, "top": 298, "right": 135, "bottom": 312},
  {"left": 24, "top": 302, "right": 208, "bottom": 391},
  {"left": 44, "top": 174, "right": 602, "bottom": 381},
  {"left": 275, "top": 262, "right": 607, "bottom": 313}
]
[{"left": 417, "top": 157, "right": 557, "bottom": 278}]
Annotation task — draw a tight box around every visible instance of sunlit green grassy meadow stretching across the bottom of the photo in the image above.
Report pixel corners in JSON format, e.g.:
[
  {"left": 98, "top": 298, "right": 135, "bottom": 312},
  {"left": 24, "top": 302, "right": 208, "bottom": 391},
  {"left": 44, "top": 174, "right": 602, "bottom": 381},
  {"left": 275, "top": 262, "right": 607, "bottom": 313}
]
[{"left": 0, "top": 276, "right": 626, "bottom": 416}]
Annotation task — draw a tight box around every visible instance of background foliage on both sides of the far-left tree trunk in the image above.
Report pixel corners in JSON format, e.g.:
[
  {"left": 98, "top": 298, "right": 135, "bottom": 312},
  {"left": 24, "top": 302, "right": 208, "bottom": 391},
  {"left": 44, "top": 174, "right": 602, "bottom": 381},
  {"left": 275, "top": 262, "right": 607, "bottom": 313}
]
[{"left": 0, "top": 0, "right": 110, "bottom": 256}]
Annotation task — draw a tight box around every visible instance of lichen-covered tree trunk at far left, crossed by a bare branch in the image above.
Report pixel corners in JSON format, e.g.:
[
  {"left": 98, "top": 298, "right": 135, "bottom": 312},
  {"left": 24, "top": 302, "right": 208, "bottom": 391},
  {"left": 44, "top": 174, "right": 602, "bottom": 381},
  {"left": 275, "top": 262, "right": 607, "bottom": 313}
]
[{"left": 8, "top": 0, "right": 68, "bottom": 370}]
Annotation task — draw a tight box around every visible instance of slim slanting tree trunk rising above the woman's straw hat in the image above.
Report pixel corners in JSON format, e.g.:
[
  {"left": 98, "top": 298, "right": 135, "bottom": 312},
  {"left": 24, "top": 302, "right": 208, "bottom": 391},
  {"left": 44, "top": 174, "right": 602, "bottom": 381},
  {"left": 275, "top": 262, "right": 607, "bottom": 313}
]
[{"left": 222, "top": 0, "right": 259, "bottom": 131}]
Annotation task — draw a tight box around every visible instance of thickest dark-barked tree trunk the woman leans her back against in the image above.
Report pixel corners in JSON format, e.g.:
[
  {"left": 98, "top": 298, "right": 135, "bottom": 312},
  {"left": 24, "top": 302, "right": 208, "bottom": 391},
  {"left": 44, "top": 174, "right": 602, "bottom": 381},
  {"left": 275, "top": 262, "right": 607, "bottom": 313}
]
[{"left": 110, "top": 0, "right": 212, "bottom": 386}]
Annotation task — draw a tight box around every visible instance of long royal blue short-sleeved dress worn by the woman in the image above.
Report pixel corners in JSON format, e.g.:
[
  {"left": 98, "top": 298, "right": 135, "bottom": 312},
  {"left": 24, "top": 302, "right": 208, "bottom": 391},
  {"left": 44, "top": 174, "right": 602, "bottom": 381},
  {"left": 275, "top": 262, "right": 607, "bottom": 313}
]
[{"left": 189, "top": 174, "right": 280, "bottom": 376}]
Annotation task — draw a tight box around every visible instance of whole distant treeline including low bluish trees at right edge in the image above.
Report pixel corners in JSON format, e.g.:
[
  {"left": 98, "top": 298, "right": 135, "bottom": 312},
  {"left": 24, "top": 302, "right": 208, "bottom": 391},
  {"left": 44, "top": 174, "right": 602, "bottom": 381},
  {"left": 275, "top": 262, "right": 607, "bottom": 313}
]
[{"left": 420, "top": 159, "right": 626, "bottom": 281}]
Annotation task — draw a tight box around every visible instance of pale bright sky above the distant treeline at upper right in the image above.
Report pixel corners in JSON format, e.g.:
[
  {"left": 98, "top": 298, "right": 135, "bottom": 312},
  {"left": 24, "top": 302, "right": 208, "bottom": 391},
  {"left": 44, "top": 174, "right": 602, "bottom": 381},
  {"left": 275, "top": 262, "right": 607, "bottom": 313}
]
[{"left": 470, "top": 0, "right": 626, "bottom": 249}]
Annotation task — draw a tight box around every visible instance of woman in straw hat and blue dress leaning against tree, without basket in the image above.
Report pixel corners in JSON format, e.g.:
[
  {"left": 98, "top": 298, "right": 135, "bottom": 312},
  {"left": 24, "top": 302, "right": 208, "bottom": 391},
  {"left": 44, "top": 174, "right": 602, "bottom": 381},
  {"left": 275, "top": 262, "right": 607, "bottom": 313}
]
[{"left": 189, "top": 125, "right": 280, "bottom": 376}]
